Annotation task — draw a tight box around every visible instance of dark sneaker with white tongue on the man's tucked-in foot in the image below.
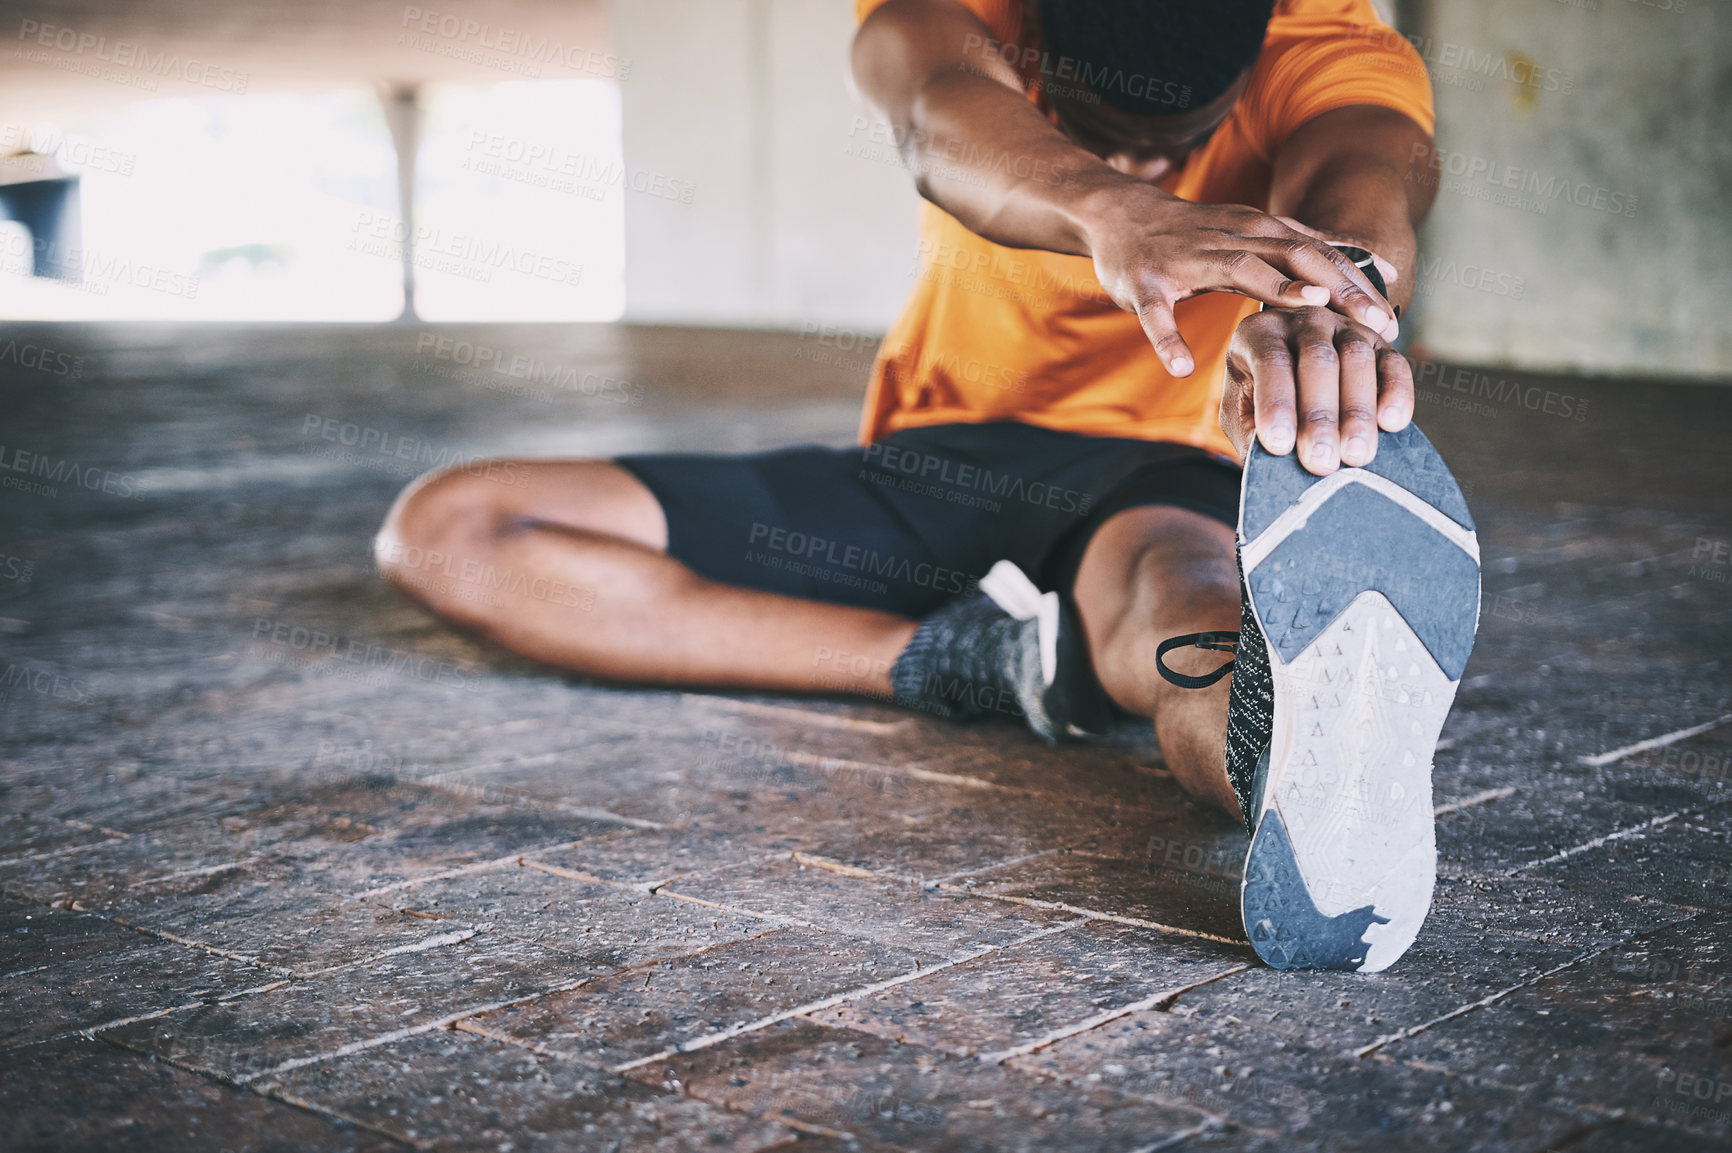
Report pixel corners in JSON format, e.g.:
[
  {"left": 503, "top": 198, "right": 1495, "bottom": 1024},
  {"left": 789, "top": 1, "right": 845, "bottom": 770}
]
[{"left": 890, "top": 561, "right": 1112, "bottom": 741}]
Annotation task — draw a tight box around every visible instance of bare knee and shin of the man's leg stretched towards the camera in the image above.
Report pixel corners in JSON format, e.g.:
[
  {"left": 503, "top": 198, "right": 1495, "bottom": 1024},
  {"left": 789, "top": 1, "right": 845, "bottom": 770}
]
[{"left": 1074, "top": 506, "right": 1238, "bottom": 815}]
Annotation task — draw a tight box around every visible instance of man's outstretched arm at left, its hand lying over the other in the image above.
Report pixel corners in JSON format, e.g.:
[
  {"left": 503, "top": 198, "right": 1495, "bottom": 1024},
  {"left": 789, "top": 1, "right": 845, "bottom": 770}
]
[{"left": 854, "top": 0, "right": 1394, "bottom": 376}]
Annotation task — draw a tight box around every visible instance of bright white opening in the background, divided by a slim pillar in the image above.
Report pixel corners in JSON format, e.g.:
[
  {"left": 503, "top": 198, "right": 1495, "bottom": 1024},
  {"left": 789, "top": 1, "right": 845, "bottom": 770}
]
[{"left": 0, "top": 80, "right": 625, "bottom": 320}]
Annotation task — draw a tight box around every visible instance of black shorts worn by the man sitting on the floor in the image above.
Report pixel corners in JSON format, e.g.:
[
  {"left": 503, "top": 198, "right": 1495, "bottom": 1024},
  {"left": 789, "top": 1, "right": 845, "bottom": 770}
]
[{"left": 617, "top": 421, "right": 1238, "bottom": 616}]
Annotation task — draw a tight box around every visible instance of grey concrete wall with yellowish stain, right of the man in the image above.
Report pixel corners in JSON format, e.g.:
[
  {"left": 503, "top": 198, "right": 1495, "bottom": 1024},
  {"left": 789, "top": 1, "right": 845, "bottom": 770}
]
[{"left": 1412, "top": 0, "right": 1732, "bottom": 377}]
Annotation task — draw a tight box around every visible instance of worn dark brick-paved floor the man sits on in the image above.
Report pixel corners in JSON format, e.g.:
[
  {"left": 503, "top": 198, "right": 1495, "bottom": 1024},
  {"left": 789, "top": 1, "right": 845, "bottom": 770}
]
[{"left": 0, "top": 316, "right": 1732, "bottom": 1153}]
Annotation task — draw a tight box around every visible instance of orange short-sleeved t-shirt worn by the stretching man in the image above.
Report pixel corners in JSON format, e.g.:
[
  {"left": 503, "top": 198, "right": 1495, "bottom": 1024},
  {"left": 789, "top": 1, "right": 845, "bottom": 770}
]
[{"left": 856, "top": 0, "right": 1432, "bottom": 455}]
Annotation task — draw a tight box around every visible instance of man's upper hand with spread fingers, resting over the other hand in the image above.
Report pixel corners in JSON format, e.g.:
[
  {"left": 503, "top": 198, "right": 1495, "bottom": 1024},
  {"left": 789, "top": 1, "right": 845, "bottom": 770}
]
[{"left": 1088, "top": 185, "right": 1399, "bottom": 377}]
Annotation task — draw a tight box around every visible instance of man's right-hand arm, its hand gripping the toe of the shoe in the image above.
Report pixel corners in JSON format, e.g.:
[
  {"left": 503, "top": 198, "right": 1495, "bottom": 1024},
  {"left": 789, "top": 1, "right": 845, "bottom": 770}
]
[{"left": 1221, "top": 106, "right": 1436, "bottom": 473}]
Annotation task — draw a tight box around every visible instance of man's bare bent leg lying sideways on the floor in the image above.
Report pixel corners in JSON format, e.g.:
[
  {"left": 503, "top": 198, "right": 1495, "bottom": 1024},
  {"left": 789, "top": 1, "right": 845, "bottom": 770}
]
[{"left": 376, "top": 461, "right": 916, "bottom": 696}]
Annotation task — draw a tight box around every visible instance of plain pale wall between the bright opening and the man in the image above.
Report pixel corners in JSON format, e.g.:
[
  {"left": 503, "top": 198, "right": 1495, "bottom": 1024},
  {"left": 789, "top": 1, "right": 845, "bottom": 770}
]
[{"left": 611, "top": 0, "right": 918, "bottom": 329}]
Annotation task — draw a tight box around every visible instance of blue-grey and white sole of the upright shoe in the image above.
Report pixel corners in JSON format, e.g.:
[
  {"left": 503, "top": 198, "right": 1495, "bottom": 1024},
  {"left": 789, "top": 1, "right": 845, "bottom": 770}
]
[{"left": 1238, "top": 424, "right": 1479, "bottom": 973}]
